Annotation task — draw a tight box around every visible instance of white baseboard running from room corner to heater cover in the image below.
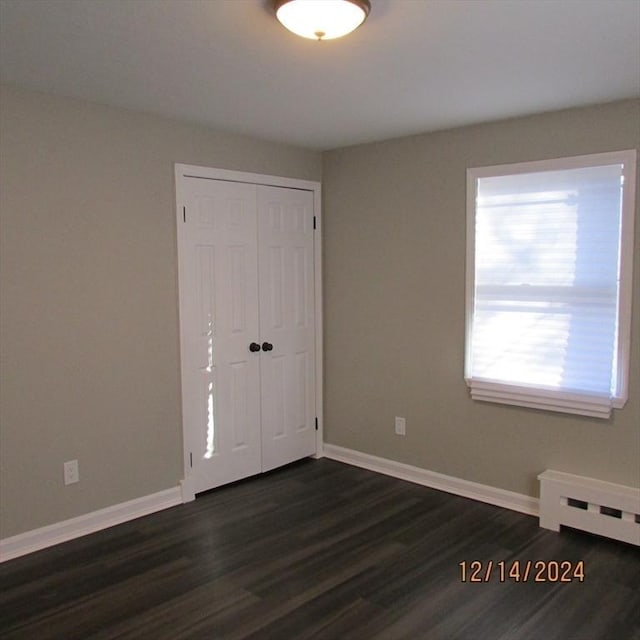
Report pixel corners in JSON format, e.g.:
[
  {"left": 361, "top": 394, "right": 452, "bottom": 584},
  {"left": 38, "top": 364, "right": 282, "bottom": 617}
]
[{"left": 324, "top": 442, "right": 540, "bottom": 516}]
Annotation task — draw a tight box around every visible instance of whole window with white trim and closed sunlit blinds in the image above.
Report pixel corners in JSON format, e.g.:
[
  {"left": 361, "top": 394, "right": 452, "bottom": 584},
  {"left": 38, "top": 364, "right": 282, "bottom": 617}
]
[{"left": 465, "top": 151, "right": 636, "bottom": 418}]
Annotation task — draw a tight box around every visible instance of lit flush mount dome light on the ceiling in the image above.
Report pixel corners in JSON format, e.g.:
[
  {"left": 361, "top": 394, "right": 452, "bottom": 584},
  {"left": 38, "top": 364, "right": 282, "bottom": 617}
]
[{"left": 273, "top": 0, "right": 371, "bottom": 40}]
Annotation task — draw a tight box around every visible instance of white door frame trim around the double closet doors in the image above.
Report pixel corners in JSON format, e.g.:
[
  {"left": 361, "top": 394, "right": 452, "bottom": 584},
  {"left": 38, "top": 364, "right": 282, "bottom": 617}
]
[{"left": 175, "top": 163, "right": 323, "bottom": 502}]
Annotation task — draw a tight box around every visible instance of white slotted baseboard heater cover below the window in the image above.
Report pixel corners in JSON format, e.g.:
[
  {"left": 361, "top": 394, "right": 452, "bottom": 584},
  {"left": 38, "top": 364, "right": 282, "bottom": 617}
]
[{"left": 538, "top": 470, "right": 640, "bottom": 546}]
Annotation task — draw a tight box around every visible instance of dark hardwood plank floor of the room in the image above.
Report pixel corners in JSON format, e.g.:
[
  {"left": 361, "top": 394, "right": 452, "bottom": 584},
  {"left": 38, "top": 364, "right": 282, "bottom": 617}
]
[{"left": 0, "top": 460, "right": 640, "bottom": 640}]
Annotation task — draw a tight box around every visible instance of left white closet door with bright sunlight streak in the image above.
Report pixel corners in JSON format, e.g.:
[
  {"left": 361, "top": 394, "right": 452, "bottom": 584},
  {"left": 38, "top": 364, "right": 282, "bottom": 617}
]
[{"left": 180, "top": 178, "right": 261, "bottom": 492}]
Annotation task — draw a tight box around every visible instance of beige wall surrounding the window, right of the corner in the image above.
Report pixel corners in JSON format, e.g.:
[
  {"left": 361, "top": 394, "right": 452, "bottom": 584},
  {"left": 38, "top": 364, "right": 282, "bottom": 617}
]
[{"left": 323, "top": 101, "right": 640, "bottom": 495}]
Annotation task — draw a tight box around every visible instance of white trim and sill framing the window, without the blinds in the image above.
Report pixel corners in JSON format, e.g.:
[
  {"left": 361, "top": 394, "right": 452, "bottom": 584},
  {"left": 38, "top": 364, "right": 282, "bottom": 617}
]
[{"left": 464, "top": 149, "right": 637, "bottom": 418}]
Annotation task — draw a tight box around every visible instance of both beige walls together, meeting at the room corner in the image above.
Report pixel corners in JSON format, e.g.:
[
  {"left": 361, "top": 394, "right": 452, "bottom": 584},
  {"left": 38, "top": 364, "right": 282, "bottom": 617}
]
[{"left": 0, "top": 81, "right": 640, "bottom": 537}]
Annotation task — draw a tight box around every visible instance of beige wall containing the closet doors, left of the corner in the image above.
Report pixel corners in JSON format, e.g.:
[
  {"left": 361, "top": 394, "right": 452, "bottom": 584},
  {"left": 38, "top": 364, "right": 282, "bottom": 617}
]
[{"left": 0, "top": 82, "right": 321, "bottom": 538}]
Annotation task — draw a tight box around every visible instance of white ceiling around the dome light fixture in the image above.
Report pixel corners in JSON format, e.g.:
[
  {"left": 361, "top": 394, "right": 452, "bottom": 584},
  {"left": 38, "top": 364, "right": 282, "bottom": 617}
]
[{"left": 0, "top": 0, "right": 640, "bottom": 149}]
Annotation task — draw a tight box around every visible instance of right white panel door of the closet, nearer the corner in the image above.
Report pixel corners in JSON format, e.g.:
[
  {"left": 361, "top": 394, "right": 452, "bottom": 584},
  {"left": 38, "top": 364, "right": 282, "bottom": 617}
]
[{"left": 258, "top": 186, "right": 316, "bottom": 471}]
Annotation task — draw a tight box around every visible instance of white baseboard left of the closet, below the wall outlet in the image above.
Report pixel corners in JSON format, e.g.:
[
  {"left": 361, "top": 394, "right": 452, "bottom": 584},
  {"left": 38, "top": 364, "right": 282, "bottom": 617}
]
[{"left": 0, "top": 487, "right": 182, "bottom": 562}]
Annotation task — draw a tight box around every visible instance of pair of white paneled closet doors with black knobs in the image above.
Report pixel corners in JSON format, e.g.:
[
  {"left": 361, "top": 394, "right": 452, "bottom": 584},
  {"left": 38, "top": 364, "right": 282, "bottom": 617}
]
[{"left": 178, "top": 176, "right": 316, "bottom": 493}]
